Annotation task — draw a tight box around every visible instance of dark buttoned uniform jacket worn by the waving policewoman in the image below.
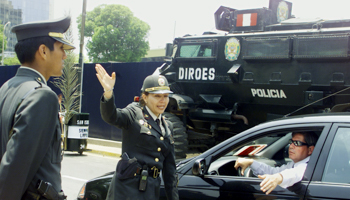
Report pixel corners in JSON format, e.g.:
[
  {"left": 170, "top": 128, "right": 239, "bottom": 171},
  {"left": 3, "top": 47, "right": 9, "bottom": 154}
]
[{"left": 100, "top": 96, "right": 179, "bottom": 200}]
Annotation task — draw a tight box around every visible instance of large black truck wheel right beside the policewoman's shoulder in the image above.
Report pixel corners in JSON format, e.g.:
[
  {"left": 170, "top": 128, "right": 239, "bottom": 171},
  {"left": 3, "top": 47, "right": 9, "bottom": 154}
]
[{"left": 163, "top": 112, "right": 188, "bottom": 159}]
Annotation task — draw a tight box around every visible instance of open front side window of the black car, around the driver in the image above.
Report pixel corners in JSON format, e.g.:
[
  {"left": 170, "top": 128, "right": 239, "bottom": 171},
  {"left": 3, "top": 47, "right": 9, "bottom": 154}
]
[{"left": 207, "top": 127, "right": 324, "bottom": 177}]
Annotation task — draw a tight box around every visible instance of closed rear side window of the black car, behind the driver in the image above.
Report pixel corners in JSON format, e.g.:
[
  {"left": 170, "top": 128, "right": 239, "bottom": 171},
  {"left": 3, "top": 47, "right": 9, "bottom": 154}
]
[{"left": 322, "top": 128, "right": 350, "bottom": 183}]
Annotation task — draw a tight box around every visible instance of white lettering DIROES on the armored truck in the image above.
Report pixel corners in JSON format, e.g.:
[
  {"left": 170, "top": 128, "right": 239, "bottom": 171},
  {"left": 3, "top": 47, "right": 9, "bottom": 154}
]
[{"left": 179, "top": 67, "right": 215, "bottom": 81}]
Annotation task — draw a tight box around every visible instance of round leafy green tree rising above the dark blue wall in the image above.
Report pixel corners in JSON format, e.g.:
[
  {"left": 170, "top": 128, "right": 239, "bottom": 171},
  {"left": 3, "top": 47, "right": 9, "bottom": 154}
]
[{"left": 77, "top": 5, "right": 150, "bottom": 63}]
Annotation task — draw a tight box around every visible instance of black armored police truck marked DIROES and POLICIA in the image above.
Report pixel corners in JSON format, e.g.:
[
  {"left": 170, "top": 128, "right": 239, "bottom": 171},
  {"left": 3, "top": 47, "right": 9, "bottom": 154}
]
[{"left": 159, "top": 0, "right": 350, "bottom": 158}]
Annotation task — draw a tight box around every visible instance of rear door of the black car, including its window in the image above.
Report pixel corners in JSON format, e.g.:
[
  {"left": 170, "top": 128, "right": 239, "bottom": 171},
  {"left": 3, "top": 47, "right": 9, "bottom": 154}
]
[{"left": 306, "top": 124, "right": 350, "bottom": 199}]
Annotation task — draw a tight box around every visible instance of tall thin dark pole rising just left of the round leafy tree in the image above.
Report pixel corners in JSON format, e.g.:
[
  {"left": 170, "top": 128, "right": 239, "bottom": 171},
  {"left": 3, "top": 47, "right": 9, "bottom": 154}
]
[{"left": 79, "top": 0, "right": 87, "bottom": 113}]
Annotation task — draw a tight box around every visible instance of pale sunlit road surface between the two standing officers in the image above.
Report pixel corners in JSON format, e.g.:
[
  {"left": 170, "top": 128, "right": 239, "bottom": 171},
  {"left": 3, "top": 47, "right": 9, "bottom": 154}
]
[{"left": 61, "top": 152, "right": 119, "bottom": 200}]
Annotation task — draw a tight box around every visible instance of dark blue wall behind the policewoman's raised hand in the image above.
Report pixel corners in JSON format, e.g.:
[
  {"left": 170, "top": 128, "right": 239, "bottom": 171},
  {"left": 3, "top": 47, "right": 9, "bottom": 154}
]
[{"left": 0, "top": 62, "right": 163, "bottom": 141}]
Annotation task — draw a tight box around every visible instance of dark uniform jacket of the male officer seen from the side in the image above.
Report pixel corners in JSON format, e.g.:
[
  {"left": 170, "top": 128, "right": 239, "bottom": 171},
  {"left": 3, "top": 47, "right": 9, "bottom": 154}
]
[{"left": 0, "top": 67, "right": 62, "bottom": 200}]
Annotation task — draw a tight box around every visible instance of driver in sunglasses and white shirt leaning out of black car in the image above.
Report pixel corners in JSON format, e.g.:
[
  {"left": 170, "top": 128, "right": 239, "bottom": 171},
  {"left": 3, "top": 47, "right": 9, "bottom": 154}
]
[{"left": 235, "top": 132, "right": 318, "bottom": 194}]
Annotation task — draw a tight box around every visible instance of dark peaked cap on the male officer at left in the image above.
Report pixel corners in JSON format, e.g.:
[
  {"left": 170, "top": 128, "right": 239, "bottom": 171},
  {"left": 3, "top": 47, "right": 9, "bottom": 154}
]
[{"left": 11, "top": 16, "right": 75, "bottom": 50}]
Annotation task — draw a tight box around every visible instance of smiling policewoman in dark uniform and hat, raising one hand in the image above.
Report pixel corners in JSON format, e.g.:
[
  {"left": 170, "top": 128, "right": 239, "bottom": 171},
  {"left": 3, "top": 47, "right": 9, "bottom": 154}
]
[{"left": 96, "top": 64, "right": 179, "bottom": 200}]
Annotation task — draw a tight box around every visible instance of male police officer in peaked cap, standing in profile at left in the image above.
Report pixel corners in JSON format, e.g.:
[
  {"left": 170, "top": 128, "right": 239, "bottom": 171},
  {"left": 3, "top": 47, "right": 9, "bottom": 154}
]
[{"left": 0, "top": 17, "right": 74, "bottom": 200}]
